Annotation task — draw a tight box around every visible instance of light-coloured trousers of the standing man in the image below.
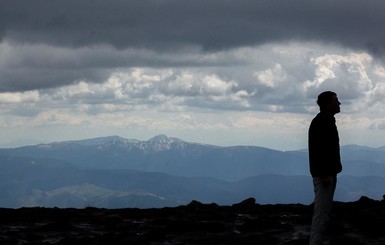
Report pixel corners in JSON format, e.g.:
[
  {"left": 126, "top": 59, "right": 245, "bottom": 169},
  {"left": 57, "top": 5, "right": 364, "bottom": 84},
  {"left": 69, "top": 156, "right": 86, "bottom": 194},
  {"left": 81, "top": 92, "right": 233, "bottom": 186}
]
[{"left": 309, "top": 176, "right": 337, "bottom": 245}]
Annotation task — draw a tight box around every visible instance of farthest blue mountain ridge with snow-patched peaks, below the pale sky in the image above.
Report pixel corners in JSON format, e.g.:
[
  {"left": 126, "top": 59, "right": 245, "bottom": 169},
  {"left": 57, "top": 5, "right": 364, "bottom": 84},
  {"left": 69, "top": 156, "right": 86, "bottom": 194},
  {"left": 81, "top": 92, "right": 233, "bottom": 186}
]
[{"left": 0, "top": 135, "right": 385, "bottom": 181}]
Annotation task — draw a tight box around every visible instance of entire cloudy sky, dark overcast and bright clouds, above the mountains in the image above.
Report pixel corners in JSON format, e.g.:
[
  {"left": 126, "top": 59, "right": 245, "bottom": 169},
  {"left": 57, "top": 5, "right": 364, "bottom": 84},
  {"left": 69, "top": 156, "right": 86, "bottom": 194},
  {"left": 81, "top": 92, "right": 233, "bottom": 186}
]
[{"left": 0, "top": 0, "right": 385, "bottom": 150}]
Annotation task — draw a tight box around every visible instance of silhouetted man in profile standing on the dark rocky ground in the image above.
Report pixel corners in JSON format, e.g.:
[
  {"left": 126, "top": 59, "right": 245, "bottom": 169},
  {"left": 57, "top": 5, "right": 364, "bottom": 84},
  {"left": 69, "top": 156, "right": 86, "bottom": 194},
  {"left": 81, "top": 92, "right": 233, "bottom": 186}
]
[{"left": 308, "top": 91, "right": 342, "bottom": 245}]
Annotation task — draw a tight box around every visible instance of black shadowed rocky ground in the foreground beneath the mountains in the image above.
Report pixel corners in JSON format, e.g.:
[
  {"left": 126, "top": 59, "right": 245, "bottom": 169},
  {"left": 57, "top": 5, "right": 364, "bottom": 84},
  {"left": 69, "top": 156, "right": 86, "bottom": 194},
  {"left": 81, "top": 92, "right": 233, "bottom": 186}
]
[{"left": 0, "top": 197, "right": 385, "bottom": 245}]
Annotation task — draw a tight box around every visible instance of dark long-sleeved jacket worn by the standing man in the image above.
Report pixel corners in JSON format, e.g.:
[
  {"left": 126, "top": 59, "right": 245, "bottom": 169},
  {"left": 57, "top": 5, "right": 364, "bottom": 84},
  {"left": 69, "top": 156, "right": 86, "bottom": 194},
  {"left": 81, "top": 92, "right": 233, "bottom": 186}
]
[{"left": 308, "top": 112, "right": 342, "bottom": 177}]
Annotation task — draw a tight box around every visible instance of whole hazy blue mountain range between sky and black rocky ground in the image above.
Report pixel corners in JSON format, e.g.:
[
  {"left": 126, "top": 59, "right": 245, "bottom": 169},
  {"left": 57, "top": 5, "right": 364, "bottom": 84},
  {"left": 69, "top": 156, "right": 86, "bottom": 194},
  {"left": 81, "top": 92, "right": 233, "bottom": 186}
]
[{"left": 0, "top": 135, "right": 385, "bottom": 208}]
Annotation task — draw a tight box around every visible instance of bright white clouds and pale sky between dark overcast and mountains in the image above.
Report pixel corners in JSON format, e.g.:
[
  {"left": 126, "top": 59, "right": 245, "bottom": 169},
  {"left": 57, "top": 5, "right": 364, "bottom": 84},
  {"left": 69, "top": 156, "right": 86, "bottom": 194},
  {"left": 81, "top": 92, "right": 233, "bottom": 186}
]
[{"left": 0, "top": 43, "right": 385, "bottom": 150}]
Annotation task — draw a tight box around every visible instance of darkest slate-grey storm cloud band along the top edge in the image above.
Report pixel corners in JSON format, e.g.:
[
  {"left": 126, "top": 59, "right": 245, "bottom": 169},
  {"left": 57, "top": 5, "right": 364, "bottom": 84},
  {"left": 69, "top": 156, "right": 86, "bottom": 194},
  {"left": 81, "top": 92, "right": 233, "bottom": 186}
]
[{"left": 0, "top": 0, "right": 385, "bottom": 52}]
